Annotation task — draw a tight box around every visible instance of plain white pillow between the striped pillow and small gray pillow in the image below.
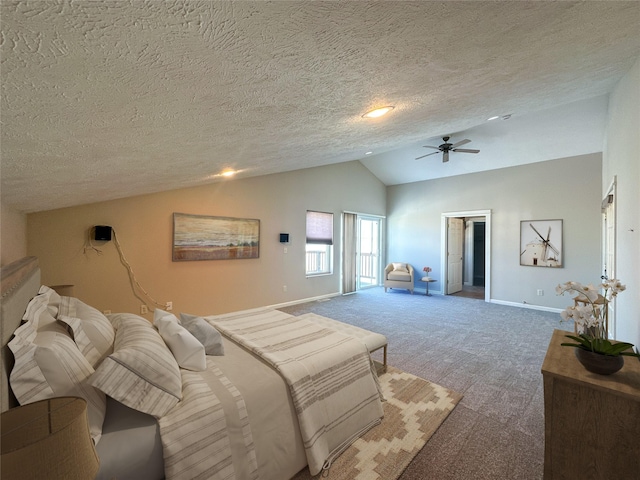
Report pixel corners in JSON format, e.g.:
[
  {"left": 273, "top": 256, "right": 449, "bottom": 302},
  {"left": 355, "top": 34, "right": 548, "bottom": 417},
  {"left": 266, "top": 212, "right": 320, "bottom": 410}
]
[{"left": 153, "top": 308, "right": 207, "bottom": 371}]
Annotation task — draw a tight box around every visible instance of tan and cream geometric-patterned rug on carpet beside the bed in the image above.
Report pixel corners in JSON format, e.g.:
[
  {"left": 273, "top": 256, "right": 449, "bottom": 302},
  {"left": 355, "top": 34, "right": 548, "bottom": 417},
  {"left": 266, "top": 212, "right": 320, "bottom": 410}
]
[{"left": 293, "top": 367, "right": 462, "bottom": 480}]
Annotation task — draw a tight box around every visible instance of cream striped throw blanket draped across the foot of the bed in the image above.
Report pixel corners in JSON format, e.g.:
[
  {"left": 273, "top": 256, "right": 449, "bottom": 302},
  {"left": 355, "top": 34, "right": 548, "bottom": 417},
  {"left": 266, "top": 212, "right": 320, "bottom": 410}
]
[{"left": 206, "top": 310, "right": 383, "bottom": 475}]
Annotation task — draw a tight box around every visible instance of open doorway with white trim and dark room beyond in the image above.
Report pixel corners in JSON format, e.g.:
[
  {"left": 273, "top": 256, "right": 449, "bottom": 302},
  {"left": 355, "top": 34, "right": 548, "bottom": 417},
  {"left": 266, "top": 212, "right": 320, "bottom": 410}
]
[{"left": 441, "top": 210, "right": 491, "bottom": 301}]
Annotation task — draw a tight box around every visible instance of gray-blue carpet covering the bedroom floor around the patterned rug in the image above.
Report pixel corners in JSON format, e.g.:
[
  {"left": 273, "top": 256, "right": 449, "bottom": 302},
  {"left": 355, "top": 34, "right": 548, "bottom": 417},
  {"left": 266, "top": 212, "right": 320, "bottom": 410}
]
[{"left": 281, "top": 287, "right": 573, "bottom": 480}]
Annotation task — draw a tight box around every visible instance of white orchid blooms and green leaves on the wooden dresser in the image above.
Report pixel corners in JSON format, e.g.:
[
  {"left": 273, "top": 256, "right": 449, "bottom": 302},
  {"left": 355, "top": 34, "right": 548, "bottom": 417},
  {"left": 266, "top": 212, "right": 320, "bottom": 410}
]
[{"left": 556, "top": 278, "right": 640, "bottom": 357}]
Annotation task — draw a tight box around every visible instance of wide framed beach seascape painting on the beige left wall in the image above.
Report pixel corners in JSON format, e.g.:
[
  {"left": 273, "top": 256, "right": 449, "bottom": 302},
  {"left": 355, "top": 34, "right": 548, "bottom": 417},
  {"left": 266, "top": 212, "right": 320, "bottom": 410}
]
[{"left": 173, "top": 213, "right": 260, "bottom": 262}]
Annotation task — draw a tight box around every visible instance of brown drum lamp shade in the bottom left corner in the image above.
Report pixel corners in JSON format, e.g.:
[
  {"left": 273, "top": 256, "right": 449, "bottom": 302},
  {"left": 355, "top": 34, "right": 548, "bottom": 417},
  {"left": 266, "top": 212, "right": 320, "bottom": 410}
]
[{"left": 0, "top": 397, "right": 100, "bottom": 480}]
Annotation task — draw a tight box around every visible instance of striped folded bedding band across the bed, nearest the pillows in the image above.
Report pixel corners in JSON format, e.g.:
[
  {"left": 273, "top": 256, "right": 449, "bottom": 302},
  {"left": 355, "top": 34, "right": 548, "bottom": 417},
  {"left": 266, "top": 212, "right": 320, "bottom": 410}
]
[{"left": 158, "top": 357, "right": 259, "bottom": 480}]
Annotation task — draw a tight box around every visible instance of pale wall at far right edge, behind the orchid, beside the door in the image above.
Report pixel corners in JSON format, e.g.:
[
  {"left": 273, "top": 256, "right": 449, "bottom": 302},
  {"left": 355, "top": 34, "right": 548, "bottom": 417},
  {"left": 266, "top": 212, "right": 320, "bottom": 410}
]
[{"left": 602, "top": 59, "right": 640, "bottom": 348}]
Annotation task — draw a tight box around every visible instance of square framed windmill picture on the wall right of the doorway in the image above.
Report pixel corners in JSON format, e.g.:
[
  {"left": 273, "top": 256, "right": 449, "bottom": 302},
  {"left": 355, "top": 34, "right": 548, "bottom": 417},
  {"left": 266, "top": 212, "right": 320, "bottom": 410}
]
[{"left": 520, "top": 220, "right": 563, "bottom": 268}]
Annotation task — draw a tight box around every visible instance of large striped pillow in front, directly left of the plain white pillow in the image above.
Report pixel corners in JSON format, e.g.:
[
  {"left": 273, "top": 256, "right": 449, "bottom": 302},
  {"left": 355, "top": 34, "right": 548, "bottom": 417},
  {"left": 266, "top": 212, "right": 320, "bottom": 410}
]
[{"left": 90, "top": 313, "right": 182, "bottom": 417}]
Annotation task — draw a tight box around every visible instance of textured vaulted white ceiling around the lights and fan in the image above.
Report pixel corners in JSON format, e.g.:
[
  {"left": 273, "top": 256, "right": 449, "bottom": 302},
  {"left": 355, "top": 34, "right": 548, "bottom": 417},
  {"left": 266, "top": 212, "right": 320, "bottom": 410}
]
[{"left": 0, "top": 0, "right": 640, "bottom": 212}]
